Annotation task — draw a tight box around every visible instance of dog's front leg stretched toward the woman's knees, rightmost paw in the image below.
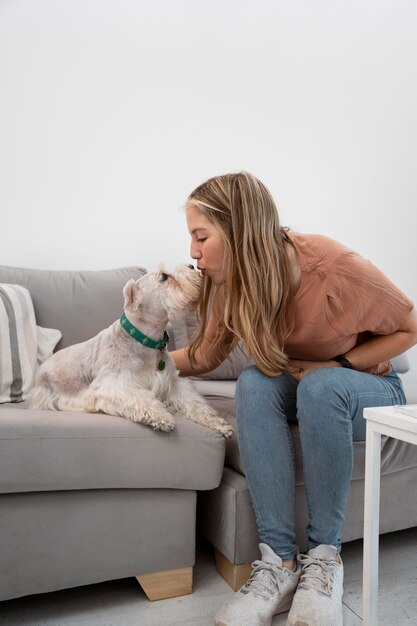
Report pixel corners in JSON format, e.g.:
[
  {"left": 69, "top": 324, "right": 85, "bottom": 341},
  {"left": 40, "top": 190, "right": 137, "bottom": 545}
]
[{"left": 169, "top": 380, "right": 234, "bottom": 438}]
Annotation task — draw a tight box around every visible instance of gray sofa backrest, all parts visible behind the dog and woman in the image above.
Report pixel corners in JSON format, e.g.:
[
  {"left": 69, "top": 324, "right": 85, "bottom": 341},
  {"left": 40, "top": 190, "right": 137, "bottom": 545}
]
[{"left": 0, "top": 265, "right": 409, "bottom": 380}]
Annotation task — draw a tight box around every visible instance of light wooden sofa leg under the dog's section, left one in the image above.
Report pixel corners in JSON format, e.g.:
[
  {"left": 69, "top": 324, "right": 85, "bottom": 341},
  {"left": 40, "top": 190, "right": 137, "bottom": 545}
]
[{"left": 136, "top": 567, "right": 193, "bottom": 600}]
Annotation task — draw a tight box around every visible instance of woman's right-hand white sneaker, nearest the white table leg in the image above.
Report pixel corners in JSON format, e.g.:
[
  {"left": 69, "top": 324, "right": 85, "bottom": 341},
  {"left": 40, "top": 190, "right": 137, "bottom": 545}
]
[{"left": 287, "top": 544, "right": 343, "bottom": 626}]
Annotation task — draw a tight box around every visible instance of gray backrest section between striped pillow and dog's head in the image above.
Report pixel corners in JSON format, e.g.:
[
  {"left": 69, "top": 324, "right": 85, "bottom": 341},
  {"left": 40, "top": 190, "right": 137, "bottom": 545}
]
[{"left": 0, "top": 265, "right": 146, "bottom": 349}]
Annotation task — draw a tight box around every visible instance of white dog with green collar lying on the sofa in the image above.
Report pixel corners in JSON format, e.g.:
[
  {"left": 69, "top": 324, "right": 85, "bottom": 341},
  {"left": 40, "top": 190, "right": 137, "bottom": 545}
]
[{"left": 29, "top": 265, "right": 233, "bottom": 437}]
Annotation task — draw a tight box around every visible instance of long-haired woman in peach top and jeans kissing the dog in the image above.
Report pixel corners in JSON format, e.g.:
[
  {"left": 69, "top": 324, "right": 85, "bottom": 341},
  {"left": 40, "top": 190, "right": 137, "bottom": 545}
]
[{"left": 172, "top": 172, "right": 417, "bottom": 626}]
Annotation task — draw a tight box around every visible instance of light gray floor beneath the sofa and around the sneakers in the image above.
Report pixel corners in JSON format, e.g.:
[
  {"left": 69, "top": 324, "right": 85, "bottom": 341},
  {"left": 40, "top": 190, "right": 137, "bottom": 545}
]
[{"left": 0, "top": 528, "right": 417, "bottom": 626}]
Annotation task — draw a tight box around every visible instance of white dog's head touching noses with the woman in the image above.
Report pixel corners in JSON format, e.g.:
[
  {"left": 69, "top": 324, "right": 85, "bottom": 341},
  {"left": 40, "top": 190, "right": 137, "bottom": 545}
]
[{"left": 123, "top": 265, "right": 203, "bottom": 322}]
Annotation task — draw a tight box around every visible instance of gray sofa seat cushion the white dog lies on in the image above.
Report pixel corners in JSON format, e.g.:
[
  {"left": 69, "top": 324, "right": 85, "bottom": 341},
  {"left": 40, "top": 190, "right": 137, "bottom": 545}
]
[{"left": 0, "top": 403, "right": 225, "bottom": 493}]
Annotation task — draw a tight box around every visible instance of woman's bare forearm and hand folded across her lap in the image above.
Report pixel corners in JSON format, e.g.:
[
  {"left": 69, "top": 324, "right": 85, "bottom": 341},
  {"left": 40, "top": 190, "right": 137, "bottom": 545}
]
[{"left": 290, "top": 309, "right": 417, "bottom": 381}]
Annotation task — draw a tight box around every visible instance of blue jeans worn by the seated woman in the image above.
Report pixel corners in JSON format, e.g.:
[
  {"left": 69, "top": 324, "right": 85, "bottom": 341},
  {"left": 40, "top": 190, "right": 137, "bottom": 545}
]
[{"left": 236, "top": 366, "right": 405, "bottom": 560}]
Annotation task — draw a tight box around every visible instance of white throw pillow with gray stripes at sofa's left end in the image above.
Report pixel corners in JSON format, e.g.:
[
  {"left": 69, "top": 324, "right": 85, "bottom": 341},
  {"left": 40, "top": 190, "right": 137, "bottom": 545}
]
[{"left": 0, "top": 283, "right": 37, "bottom": 402}]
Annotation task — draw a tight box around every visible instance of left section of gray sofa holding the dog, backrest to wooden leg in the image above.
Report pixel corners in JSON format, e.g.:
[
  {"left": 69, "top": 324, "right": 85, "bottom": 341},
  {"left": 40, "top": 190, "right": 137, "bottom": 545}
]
[{"left": 0, "top": 267, "right": 225, "bottom": 600}]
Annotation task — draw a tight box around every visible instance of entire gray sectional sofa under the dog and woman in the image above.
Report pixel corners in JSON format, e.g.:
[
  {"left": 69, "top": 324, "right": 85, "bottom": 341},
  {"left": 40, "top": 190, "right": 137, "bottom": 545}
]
[{"left": 0, "top": 267, "right": 417, "bottom": 600}]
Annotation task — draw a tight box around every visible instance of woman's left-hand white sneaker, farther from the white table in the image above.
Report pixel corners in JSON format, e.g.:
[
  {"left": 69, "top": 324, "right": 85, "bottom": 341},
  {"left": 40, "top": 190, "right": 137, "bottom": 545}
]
[{"left": 214, "top": 543, "right": 301, "bottom": 626}]
